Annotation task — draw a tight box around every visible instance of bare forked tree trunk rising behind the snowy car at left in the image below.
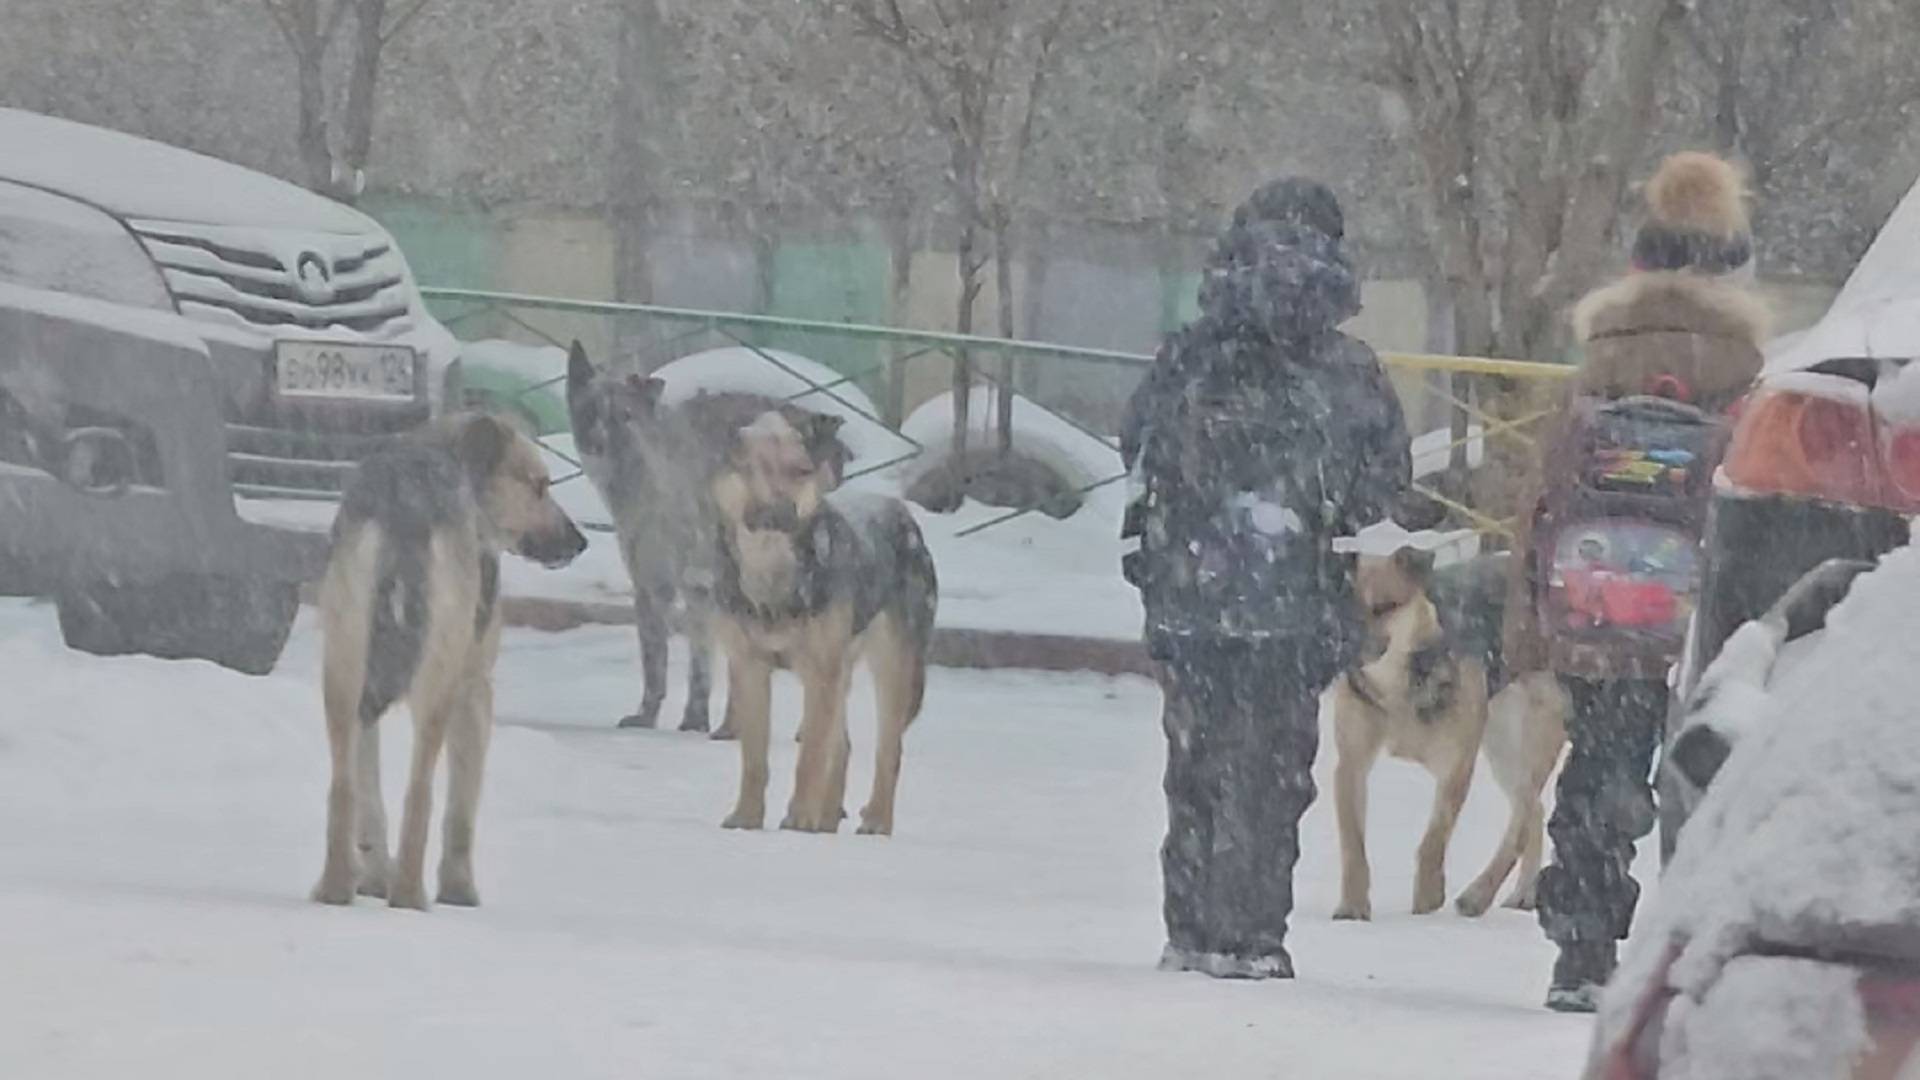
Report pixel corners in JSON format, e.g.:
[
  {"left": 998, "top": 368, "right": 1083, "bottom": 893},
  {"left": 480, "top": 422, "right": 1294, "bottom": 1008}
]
[{"left": 259, "top": 0, "right": 432, "bottom": 202}]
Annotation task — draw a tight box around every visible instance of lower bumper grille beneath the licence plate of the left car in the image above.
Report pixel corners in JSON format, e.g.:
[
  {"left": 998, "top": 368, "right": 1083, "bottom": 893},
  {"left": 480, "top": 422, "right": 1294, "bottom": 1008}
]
[{"left": 227, "top": 402, "right": 428, "bottom": 500}]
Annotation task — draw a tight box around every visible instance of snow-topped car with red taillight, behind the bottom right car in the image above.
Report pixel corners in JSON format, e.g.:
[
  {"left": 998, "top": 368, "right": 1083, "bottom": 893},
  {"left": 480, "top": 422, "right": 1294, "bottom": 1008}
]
[{"left": 1661, "top": 178, "right": 1920, "bottom": 857}]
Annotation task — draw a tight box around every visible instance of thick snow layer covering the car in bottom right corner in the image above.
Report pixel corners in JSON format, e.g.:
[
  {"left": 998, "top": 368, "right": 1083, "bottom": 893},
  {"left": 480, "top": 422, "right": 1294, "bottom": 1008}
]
[{"left": 1601, "top": 548, "right": 1920, "bottom": 1040}]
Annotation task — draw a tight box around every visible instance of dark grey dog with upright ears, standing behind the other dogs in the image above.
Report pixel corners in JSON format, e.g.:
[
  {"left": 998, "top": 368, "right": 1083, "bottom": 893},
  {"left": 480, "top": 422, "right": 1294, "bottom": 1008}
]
[{"left": 566, "top": 342, "right": 849, "bottom": 738}]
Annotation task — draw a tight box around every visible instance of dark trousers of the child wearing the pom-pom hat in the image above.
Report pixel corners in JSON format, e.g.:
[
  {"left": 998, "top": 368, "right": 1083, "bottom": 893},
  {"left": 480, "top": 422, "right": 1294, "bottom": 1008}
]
[{"left": 1538, "top": 678, "right": 1667, "bottom": 945}]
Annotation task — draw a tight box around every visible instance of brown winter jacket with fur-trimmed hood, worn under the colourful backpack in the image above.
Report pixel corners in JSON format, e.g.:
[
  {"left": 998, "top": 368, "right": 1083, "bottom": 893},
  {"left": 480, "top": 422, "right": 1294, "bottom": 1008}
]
[{"left": 1503, "top": 271, "right": 1768, "bottom": 678}]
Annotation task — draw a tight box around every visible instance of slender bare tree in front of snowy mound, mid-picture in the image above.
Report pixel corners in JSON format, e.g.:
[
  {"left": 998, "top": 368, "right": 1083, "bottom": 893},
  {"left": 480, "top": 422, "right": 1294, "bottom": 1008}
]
[{"left": 828, "top": 0, "right": 1085, "bottom": 463}]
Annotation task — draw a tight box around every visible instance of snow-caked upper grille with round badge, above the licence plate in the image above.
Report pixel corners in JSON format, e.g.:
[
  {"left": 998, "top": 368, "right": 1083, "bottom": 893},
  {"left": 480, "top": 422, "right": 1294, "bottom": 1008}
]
[{"left": 131, "top": 221, "right": 413, "bottom": 338}]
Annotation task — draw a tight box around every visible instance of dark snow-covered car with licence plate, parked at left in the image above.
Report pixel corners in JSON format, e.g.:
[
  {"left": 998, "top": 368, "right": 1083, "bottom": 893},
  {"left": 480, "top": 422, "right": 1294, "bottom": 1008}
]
[{"left": 0, "top": 110, "right": 457, "bottom": 671}]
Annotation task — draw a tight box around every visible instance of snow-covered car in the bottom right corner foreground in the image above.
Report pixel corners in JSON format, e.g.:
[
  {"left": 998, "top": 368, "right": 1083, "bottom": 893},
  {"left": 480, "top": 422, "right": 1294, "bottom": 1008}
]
[{"left": 1586, "top": 552, "right": 1920, "bottom": 1080}]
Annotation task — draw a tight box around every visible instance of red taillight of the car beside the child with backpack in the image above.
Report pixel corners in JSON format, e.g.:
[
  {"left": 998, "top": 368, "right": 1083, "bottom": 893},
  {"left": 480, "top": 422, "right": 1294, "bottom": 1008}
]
[{"left": 1722, "top": 379, "right": 1882, "bottom": 505}]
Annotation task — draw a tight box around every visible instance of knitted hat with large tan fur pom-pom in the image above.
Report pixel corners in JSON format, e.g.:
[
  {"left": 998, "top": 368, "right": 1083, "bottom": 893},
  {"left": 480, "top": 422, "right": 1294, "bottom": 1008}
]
[{"left": 1632, "top": 150, "right": 1753, "bottom": 277}]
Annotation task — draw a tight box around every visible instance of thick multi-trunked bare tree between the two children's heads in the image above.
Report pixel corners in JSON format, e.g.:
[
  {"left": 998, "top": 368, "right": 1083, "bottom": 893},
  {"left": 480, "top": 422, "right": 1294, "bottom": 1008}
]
[{"left": 1359, "top": 0, "right": 1686, "bottom": 359}]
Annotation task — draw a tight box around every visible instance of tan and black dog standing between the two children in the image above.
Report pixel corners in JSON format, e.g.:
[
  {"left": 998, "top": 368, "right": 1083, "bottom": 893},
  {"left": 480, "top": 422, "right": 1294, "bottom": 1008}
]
[{"left": 1332, "top": 548, "right": 1571, "bottom": 919}]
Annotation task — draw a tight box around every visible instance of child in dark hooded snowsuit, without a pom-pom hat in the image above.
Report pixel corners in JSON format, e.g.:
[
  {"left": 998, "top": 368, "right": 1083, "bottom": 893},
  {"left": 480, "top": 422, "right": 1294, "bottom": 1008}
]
[{"left": 1121, "top": 181, "right": 1411, "bottom": 978}]
